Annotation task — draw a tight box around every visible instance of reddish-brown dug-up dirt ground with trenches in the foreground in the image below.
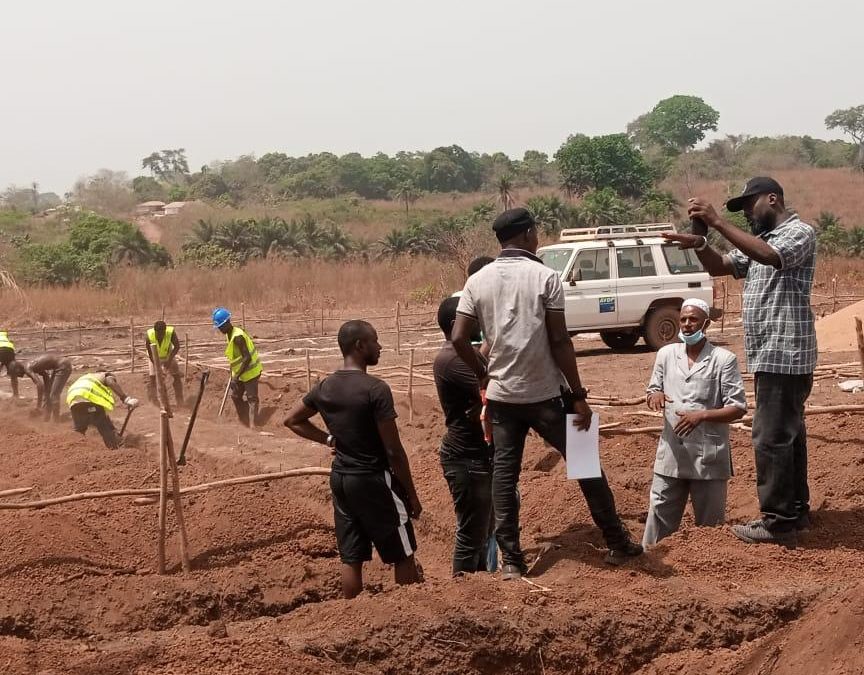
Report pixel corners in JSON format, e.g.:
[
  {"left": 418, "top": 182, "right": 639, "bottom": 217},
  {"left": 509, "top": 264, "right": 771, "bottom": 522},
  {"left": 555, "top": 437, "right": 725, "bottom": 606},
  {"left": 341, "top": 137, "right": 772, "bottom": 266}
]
[{"left": 0, "top": 330, "right": 864, "bottom": 675}]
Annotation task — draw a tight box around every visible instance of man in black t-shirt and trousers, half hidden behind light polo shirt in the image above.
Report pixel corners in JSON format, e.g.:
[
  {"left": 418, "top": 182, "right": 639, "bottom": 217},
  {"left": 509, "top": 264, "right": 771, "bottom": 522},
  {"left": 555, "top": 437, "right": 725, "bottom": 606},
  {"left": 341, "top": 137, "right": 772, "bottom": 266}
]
[{"left": 432, "top": 297, "right": 492, "bottom": 576}]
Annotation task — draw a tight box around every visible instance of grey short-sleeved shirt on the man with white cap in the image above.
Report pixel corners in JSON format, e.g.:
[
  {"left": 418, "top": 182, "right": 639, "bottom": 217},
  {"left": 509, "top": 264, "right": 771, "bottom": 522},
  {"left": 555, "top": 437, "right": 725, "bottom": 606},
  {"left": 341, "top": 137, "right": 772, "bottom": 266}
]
[{"left": 647, "top": 341, "right": 747, "bottom": 480}]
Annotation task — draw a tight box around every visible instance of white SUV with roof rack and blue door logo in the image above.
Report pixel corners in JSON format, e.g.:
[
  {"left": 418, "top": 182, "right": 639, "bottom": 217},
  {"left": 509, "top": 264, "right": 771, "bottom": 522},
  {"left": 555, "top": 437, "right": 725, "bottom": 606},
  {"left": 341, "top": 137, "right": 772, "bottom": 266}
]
[{"left": 537, "top": 223, "right": 720, "bottom": 350}]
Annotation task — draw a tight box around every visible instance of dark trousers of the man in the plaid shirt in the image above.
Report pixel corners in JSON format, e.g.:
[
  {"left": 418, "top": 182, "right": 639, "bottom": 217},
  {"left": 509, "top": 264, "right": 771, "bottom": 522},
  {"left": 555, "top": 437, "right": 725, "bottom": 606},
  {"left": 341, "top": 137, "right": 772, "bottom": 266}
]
[{"left": 753, "top": 373, "right": 813, "bottom": 532}]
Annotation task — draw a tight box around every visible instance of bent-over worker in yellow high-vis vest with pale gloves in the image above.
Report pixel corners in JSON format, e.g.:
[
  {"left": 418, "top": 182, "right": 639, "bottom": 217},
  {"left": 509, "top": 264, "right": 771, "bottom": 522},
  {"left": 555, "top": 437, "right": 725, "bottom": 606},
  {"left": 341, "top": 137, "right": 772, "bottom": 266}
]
[{"left": 66, "top": 372, "right": 138, "bottom": 450}]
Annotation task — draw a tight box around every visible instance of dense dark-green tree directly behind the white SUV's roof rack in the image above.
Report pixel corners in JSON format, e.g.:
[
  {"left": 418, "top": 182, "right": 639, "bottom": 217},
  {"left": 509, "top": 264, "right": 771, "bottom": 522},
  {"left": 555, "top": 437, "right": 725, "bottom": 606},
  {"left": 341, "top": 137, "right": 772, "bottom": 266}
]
[{"left": 555, "top": 134, "right": 652, "bottom": 197}]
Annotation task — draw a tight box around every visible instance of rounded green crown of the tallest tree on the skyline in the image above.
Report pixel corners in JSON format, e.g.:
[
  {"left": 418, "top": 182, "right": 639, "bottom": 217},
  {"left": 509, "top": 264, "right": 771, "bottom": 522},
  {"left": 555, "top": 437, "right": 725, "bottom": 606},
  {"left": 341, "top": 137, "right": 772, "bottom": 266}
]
[{"left": 641, "top": 94, "right": 720, "bottom": 154}]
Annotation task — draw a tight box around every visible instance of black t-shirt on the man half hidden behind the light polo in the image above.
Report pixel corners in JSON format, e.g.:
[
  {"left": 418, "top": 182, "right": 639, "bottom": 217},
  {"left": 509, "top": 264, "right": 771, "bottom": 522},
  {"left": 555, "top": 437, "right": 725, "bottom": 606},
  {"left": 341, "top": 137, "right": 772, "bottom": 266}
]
[{"left": 432, "top": 342, "right": 490, "bottom": 459}]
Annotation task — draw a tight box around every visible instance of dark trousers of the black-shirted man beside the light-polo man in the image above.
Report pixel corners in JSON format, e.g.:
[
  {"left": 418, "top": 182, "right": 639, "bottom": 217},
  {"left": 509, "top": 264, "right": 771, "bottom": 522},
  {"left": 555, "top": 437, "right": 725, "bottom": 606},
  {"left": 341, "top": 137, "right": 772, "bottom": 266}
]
[{"left": 441, "top": 454, "right": 492, "bottom": 574}]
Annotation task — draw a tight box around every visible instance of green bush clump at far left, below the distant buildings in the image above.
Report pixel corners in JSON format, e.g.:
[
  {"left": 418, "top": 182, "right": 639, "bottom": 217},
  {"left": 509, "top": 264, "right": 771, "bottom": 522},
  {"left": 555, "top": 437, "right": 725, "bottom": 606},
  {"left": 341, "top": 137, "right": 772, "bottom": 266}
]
[{"left": 18, "top": 213, "right": 171, "bottom": 285}]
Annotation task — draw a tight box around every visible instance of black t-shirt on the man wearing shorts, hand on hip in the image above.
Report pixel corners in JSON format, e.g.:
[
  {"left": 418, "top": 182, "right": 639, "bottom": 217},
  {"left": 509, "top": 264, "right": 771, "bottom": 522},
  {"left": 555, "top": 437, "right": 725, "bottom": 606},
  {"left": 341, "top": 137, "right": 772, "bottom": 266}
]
[{"left": 303, "top": 370, "right": 396, "bottom": 474}]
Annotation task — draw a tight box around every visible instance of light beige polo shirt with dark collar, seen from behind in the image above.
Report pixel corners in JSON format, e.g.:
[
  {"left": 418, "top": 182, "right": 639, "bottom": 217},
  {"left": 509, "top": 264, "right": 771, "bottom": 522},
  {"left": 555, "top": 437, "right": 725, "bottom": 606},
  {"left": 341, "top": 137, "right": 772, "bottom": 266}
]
[{"left": 456, "top": 249, "right": 566, "bottom": 404}]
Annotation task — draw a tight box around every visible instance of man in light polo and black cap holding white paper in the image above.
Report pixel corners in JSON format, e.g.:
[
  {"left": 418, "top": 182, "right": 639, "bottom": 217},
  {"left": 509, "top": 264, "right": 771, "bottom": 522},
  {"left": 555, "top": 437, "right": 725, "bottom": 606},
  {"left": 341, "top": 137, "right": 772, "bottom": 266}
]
[{"left": 452, "top": 208, "right": 642, "bottom": 580}]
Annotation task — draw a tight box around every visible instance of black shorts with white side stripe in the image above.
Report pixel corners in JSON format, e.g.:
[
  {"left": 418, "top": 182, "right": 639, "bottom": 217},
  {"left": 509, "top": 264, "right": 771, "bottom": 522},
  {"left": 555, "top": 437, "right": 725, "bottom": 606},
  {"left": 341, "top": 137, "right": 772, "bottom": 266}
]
[{"left": 330, "top": 471, "right": 417, "bottom": 565}]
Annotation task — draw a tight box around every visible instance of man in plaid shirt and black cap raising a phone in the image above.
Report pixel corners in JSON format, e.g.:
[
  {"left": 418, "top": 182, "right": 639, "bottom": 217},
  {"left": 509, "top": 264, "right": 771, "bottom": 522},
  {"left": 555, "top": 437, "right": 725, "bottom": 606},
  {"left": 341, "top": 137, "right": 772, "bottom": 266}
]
[{"left": 663, "top": 177, "right": 817, "bottom": 546}]
